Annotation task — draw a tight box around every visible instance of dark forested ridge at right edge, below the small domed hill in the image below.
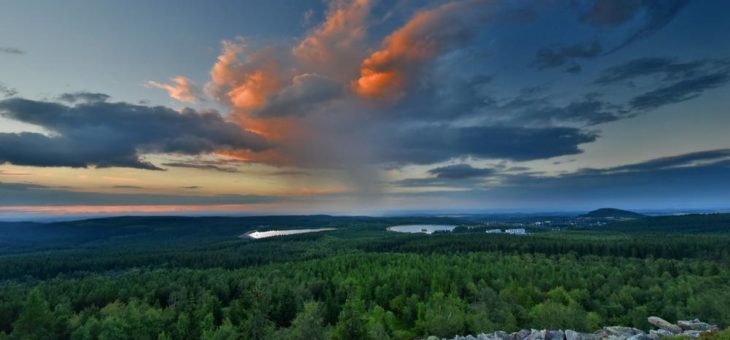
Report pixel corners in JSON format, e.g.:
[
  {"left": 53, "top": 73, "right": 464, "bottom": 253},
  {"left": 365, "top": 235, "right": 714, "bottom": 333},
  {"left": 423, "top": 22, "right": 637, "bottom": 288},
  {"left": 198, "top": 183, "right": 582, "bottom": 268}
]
[{"left": 597, "top": 214, "right": 730, "bottom": 233}]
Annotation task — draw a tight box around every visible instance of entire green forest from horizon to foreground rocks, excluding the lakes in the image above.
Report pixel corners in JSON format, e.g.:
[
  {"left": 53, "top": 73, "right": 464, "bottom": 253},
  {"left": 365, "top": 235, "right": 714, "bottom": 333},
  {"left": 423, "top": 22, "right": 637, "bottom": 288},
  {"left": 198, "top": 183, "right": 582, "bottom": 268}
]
[{"left": 0, "top": 216, "right": 730, "bottom": 339}]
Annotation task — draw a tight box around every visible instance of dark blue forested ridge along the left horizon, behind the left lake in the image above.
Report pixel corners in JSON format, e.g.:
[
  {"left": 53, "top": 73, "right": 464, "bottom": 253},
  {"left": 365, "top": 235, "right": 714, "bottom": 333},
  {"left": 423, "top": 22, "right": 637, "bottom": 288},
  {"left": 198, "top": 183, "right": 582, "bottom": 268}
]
[{"left": 0, "top": 215, "right": 460, "bottom": 253}]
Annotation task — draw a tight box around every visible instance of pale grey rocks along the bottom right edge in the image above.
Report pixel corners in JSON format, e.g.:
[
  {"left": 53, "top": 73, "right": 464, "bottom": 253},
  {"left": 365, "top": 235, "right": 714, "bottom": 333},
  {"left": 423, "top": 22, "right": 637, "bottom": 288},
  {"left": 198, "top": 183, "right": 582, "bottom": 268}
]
[{"left": 440, "top": 316, "right": 719, "bottom": 340}]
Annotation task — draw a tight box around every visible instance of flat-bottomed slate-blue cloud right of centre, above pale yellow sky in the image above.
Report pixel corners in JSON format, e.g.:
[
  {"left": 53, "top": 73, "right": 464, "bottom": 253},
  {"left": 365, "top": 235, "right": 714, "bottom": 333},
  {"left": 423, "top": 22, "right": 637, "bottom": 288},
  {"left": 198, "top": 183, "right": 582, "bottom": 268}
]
[{"left": 384, "top": 126, "right": 597, "bottom": 164}]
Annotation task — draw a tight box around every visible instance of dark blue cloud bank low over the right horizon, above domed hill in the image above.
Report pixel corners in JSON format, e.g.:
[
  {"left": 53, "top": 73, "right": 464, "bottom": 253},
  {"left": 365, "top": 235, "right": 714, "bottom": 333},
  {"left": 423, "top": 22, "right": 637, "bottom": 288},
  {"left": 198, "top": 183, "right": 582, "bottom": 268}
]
[{"left": 486, "top": 149, "right": 730, "bottom": 208}]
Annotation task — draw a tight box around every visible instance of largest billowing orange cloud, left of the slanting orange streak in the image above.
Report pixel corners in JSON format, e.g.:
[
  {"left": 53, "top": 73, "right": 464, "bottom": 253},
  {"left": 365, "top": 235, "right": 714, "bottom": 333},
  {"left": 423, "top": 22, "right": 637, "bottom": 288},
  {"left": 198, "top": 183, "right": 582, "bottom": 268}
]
[{"left": 206, "top": 0, "right": 371, "bottom": 165}]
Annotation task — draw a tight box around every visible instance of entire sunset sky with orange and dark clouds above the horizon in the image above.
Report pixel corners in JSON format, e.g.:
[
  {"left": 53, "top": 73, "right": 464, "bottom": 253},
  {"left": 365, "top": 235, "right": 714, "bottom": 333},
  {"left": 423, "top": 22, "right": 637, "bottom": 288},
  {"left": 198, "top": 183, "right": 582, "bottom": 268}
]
[{"left": 0, "top": 0, "right": 730, "bottom": 218}]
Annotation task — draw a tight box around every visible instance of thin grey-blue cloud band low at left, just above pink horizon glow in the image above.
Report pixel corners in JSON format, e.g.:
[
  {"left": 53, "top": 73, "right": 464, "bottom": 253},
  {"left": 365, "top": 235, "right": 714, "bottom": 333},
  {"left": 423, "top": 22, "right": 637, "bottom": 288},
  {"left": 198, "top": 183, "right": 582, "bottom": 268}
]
[{"left": 0, "top": 183, "right": 280, "bottom": 206}]
